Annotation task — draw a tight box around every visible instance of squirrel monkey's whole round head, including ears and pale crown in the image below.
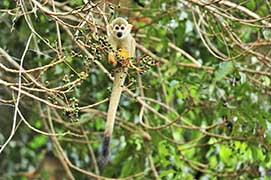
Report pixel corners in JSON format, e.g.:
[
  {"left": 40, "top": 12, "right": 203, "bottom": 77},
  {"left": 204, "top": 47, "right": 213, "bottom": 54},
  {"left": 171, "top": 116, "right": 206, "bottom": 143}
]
[{"left": 109, "top": 17, "right": 132, "bottom": 40}]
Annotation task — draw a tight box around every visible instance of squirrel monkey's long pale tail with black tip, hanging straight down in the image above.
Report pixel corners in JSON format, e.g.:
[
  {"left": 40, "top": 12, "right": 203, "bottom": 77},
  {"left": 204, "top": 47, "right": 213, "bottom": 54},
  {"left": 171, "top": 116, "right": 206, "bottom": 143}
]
[{"left": 100, "top": 68, "right": 126, "bottom": 166}]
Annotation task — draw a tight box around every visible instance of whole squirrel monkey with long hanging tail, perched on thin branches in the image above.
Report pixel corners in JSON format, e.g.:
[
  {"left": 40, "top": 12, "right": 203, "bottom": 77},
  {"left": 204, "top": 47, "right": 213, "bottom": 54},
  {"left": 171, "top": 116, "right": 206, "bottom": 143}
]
[{"left": 101, "top": 17, "right": 136, "bottom": 165}]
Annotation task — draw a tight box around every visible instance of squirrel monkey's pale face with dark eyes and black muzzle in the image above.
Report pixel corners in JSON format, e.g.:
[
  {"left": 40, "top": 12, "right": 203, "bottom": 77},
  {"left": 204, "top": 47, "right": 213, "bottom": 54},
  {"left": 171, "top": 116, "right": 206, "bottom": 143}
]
[{"left": 111, "top": 24, "right": 132, "bottom": 39}]
